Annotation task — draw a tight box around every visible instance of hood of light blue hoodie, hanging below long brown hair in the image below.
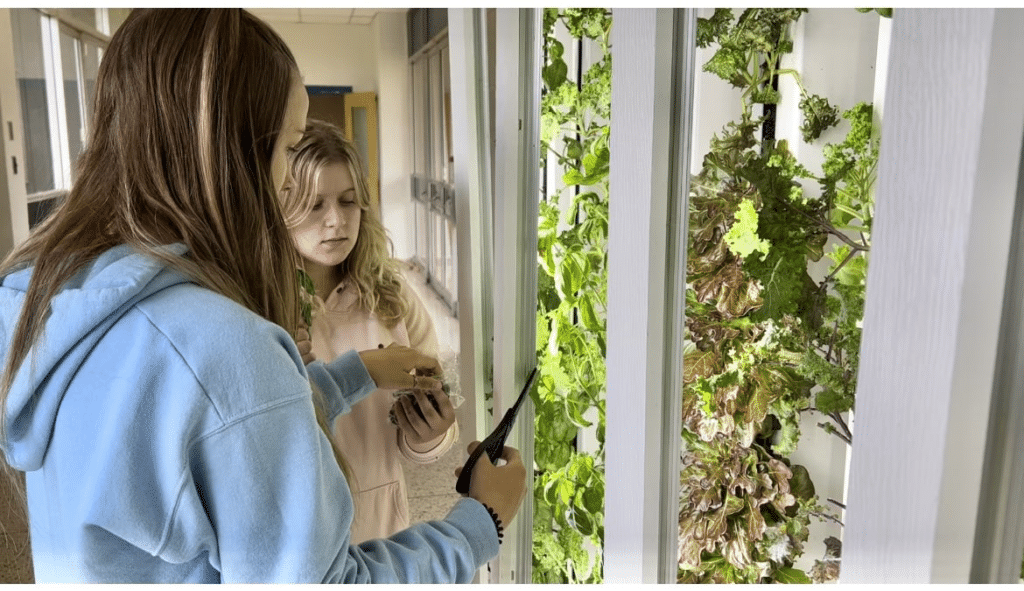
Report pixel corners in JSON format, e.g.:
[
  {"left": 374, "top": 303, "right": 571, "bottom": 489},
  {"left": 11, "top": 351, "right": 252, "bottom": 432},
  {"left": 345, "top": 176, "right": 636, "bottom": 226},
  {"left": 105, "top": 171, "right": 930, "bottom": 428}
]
[{"left": 0, "top": 244, "right": 188, "bottom": 471}]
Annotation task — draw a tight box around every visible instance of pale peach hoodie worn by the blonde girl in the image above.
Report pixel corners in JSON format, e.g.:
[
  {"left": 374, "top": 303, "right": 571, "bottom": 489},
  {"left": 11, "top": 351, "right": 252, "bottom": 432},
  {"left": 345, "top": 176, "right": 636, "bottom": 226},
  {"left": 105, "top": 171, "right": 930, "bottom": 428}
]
[{"left": 309, "top": 276, "right": 459, "bottom": 544}]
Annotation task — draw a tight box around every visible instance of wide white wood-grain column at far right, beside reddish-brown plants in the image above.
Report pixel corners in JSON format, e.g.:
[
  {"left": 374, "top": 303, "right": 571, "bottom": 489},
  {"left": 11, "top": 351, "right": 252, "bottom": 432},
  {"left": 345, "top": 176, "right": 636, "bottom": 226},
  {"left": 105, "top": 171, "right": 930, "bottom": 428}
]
[{"left": 841, "top": 8, "right": 1024, "bottom": 583}]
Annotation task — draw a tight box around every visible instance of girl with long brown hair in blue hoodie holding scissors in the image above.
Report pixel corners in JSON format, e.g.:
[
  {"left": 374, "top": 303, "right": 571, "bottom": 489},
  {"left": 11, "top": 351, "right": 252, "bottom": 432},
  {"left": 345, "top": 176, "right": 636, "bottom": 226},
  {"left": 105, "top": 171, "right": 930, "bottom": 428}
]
[{"left": 0, "top": 9, "right": 525, "bottom": 582}]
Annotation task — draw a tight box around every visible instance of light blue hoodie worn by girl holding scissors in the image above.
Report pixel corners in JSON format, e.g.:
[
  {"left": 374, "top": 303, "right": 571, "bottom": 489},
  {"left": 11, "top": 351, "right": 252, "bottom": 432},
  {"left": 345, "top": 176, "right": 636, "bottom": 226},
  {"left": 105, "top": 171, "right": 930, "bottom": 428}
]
[{"left": 0, "top": 245, "right": 498, "bottom": 583}]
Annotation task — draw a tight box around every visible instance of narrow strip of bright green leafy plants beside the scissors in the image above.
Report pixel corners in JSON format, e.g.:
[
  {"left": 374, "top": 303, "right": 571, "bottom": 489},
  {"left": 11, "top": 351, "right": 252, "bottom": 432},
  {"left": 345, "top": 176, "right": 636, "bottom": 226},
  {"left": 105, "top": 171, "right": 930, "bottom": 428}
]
[{"left": 534, "top": 8, "right": 611, "bottom": 583}]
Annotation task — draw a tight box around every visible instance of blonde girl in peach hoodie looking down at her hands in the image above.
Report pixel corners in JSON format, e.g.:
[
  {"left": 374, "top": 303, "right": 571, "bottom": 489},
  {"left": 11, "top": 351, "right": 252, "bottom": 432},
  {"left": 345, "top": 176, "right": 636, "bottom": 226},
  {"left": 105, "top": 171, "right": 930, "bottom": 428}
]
[{"left": 282, "top": 120, "right": 459, "bottom": 543}]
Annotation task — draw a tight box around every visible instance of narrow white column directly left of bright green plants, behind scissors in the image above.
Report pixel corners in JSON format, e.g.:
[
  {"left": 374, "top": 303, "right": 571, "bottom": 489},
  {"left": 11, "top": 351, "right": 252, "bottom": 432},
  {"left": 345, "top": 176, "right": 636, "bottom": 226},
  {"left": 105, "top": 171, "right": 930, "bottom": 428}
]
[{"left": 493, "top": 8, "right": 541, "bottom": 583}]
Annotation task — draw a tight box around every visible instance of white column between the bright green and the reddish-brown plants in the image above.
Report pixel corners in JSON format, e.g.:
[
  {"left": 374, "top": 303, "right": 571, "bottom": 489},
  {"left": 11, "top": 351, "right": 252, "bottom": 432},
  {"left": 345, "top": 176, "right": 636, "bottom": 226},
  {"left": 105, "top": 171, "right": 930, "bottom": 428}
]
[{"left": 604, "top": 9, "right": 695, "bottom": 583}]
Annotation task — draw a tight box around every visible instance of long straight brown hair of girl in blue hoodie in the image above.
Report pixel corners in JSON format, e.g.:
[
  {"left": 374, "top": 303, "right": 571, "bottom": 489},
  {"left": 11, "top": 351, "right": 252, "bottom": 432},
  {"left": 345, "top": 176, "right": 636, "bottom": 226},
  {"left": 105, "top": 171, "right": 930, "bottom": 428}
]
[{"left": 0, "top": 8, "right": 344, "bottom": 508}]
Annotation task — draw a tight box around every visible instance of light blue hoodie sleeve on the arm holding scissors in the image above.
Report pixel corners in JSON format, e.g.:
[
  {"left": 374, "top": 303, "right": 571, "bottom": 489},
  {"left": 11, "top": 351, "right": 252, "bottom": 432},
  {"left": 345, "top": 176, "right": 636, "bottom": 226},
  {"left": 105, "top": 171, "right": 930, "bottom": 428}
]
[{"left": 180, "top": 396, "right": 498, "bottom": 583}]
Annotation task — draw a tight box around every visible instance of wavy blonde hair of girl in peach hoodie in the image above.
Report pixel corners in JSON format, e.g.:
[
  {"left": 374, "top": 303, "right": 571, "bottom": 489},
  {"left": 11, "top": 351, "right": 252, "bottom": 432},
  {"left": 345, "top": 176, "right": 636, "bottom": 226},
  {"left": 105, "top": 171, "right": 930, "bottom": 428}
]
[{"left": 282, "top": 119, "right": 409, "bottom": 328}]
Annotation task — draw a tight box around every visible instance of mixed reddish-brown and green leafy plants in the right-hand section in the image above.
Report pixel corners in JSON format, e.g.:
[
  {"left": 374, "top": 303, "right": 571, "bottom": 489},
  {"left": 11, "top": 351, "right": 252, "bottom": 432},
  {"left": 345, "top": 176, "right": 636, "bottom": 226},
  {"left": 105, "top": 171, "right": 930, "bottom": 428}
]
[{"left": 679, "top": 8, "right": 878, "bottom": 583}]
